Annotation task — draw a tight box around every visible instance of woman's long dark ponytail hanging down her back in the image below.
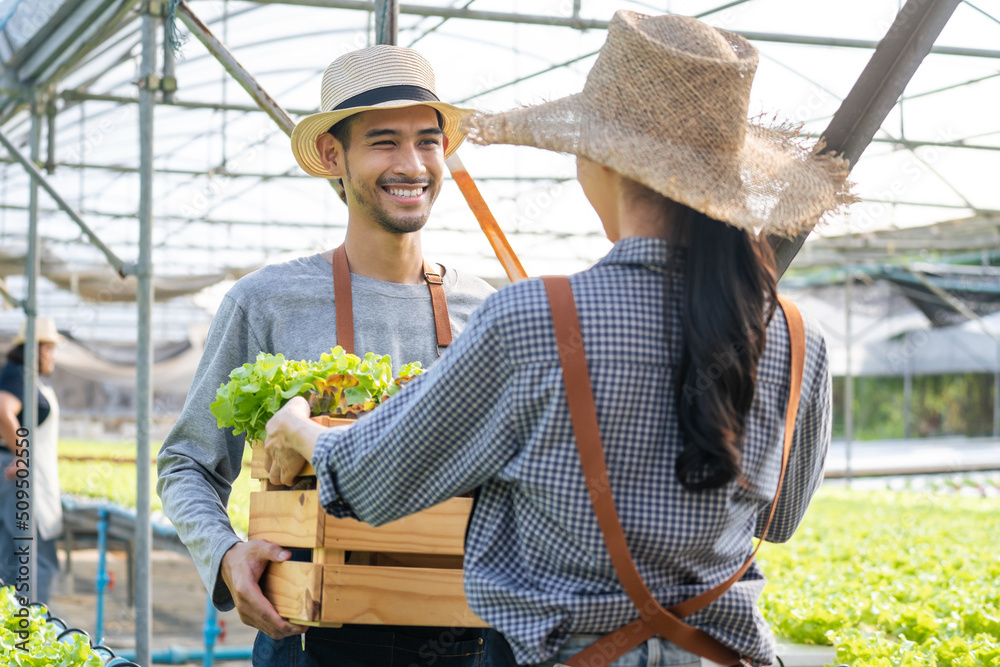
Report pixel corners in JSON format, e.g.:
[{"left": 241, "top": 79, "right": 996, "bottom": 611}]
[{"left": 666, "top": 204, "right": 777, "bottom": 491}]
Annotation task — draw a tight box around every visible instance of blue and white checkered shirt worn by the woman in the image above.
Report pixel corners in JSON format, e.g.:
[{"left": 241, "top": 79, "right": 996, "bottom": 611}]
[{"left": 313, "top": 238, "right": 831, "bottom": 664}]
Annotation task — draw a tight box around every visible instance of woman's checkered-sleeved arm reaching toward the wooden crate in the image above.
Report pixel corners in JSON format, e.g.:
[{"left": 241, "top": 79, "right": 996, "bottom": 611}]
[{"left": 312, "top": 294, "right": 520, "bottom": 525}]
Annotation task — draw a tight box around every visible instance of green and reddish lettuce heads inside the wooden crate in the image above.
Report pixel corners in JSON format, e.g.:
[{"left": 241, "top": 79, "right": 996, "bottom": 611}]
[{"left": 210, "top": 345, "right": 423, "bottom": 441}]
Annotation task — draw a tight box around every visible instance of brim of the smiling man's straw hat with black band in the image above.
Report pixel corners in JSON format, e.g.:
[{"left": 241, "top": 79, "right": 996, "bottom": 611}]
[{"left": 292, "top": 100, "right": 476, "bottom": 178}]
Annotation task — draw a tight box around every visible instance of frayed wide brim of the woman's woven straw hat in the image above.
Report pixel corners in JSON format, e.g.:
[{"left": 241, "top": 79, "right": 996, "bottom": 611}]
[{"left": 466, "top": 93, "right": 855, "bottom": 237}]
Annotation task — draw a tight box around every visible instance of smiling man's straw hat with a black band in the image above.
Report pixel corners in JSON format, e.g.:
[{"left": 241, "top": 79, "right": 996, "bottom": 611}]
[{"left": 292, "top": 44, "right": 474, "bottom": 178}]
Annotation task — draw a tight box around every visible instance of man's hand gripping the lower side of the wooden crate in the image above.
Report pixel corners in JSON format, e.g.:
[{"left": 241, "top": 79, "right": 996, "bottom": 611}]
[{"left": 220, "top": 540, "right": 308, "bottom": 639}]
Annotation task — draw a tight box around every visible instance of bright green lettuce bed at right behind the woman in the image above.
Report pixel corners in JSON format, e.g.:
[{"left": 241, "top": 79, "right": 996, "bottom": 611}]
[{"left": 760, "top": 488, "right": 1000, "bottom": 667}]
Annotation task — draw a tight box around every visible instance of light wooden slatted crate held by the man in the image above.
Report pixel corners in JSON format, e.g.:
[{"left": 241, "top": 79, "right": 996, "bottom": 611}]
[{"left": 249, "top": 418, "right": 487, "bottom": 627}]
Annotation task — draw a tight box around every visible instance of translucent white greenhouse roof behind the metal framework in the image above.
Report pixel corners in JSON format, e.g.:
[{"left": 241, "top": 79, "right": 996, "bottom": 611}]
[{"left": 0, "top": 0, "right": 1000, "bottom": 338}]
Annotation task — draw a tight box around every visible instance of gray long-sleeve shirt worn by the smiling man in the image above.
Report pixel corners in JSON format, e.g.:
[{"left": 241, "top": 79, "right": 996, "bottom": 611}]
[{"left": 156, "top": 254, "right": 493, "bottom": 611}]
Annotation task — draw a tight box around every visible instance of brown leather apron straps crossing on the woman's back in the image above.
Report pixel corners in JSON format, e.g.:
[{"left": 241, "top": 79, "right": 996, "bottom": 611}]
[{"left": 543, "top": 277, "right": 805, "bottom": 667}]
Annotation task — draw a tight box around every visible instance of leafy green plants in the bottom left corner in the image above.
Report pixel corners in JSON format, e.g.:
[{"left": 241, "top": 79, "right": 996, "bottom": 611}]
[{"left": 0, "top": 586, "right": 104, "bottom": 667}]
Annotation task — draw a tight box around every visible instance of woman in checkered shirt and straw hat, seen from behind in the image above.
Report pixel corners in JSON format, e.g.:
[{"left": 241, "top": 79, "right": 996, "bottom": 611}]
[{"left": 266, "top": 11, "right": 850, "bottom": 666}]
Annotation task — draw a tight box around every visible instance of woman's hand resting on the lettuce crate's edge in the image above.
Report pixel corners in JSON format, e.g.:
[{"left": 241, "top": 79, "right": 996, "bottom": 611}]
[{"left": 264, "top": 396, "right": 324, "bottom": 486}]
